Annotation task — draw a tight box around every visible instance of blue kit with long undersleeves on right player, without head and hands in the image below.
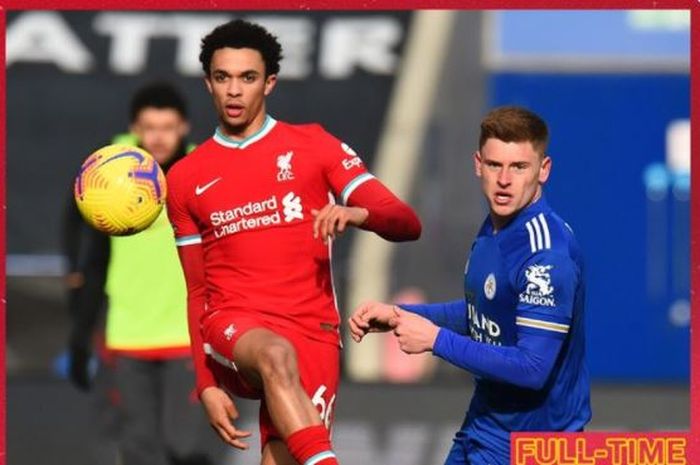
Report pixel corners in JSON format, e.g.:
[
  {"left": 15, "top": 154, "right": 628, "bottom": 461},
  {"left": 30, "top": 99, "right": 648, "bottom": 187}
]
[{"left": 402, "top": 198, "right": 591, "bottom": 465}]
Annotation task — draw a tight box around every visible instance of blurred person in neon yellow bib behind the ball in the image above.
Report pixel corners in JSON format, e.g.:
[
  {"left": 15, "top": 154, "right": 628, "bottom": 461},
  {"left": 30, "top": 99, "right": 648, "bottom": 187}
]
[{"left": 66, "top": 82, "right": 223, "bottom": 465}]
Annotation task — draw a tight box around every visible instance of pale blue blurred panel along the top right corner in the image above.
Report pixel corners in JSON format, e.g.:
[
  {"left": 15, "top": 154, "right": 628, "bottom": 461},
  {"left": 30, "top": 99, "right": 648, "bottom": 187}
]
[{"left": 486, "top": 10, "right": 690, "bottom": 70}]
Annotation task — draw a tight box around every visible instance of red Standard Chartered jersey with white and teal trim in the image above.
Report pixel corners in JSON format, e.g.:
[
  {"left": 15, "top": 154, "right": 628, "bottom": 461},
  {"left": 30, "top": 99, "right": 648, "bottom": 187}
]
[{"left": 167, "top": 116, "right": 373, "bottom": 344}]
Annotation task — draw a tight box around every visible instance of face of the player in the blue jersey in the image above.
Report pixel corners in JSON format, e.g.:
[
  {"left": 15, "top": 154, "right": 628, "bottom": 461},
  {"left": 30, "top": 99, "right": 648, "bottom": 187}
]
[{"left": 474, "top": 138, "right": 552, "bottom": 228}]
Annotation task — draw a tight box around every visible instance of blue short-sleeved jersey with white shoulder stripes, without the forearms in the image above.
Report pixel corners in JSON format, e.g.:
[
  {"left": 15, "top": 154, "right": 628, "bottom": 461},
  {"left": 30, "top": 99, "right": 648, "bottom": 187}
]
[{"left": 464, "top": 194, "right": 591, "bottom": 454}]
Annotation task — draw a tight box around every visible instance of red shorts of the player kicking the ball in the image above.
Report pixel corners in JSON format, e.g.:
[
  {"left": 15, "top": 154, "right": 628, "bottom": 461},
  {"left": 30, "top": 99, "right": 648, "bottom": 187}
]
[{"left": 202, "top": 311, "right": 340, "bottom": 448}]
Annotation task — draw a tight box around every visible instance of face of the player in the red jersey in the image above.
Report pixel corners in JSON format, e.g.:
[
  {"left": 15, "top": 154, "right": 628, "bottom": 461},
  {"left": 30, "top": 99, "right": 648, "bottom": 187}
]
[{"left": 206, "top": 47, "right": 277, "bottom": 138}]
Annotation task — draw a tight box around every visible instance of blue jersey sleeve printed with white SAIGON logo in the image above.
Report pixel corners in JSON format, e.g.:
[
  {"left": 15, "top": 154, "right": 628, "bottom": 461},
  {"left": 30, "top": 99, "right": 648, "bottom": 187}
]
[{"left": 514, "top": 250, "right": 580, "bottom": 339}]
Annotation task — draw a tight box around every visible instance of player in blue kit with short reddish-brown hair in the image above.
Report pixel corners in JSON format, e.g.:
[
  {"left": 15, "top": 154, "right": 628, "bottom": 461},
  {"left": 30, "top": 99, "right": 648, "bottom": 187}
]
[{"left": 349, "top": 107, "right": 591, "bottom": 465}]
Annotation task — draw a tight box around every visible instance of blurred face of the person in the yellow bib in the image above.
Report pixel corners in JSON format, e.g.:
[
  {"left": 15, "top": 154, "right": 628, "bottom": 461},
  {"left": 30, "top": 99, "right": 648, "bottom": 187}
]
[{"left": 130, "top": 107, "right": 190, "bottom": 165}]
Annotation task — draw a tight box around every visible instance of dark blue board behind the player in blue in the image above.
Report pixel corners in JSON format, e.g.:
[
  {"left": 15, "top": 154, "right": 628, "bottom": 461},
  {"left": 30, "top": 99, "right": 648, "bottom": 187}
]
[{"left": 490, "top": 74, "right": 690, "bottom": 380}]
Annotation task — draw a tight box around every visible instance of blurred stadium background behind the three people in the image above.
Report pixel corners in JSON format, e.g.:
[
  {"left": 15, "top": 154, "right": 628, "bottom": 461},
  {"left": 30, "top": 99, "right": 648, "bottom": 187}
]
[{"left": 6, "top": 11, "right": 690, "bottom": 465}]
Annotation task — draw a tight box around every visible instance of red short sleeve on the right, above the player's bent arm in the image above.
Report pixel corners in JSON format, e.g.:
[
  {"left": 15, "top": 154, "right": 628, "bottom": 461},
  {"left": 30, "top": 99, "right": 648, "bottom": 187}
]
[{"left": 317, "top": 126, "right": 374, "bottom": 205}]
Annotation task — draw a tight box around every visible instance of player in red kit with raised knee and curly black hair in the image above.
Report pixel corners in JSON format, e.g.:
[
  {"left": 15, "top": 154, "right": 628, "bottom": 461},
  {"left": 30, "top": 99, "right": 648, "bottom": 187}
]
[{"left": 168, "top": 20, "right": 421, "bottom": 465}]
